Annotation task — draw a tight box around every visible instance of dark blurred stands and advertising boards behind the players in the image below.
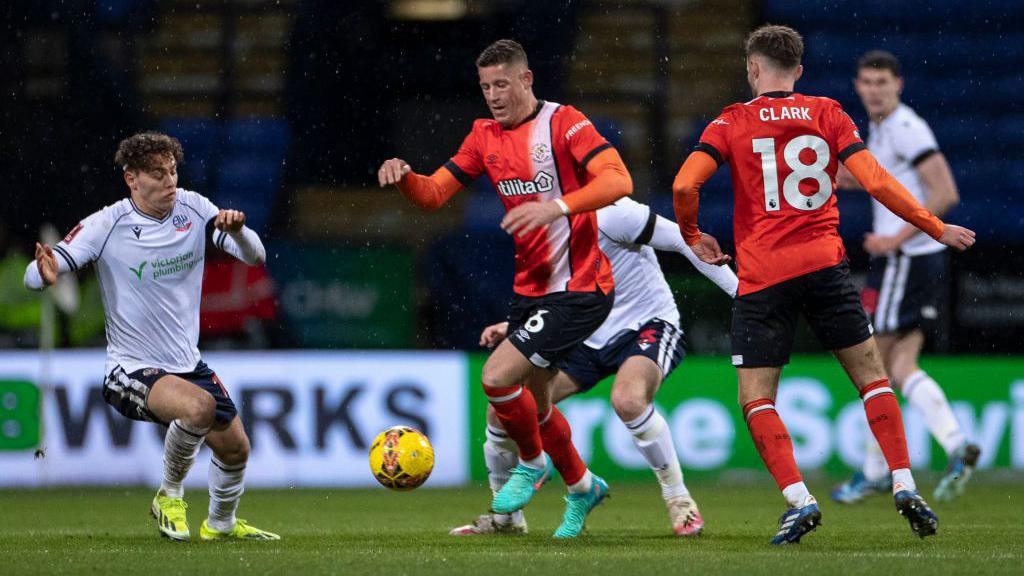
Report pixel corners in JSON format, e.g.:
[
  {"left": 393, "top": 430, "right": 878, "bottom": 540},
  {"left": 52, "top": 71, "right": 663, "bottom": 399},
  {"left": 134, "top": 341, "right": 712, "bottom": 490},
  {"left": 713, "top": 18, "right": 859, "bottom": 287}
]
[{"left": 0, "top": 0, "right": 1024, "bottom": 486}]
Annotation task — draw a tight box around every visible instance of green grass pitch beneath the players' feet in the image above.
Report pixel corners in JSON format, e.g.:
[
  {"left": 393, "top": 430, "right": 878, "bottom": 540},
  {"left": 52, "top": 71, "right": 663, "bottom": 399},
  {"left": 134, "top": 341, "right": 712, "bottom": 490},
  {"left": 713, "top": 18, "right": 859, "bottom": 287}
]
[{"left": 0, "top": 481, "right": 1024, "bottom": 576}]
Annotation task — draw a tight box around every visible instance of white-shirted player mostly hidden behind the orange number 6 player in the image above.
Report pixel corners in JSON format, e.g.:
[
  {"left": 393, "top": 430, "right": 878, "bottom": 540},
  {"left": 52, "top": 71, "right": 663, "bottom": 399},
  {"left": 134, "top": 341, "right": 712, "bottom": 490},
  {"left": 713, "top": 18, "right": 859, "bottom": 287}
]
[{"left": 451, "top": 198, "right": 738, "bottom": 536}]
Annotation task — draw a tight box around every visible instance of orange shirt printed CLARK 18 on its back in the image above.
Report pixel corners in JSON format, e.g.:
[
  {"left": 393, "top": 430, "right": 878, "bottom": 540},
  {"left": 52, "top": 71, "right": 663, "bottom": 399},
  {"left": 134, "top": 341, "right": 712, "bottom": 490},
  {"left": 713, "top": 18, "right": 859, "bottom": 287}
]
[{"left": 696, "top": 92, "right": 865, "bottom": 294}]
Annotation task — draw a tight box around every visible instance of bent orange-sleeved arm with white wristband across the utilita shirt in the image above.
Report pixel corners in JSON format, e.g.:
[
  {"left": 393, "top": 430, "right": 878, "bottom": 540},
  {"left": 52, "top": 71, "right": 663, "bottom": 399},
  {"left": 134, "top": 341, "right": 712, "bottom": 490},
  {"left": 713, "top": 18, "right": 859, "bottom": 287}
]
[{"left": 501, "top": 148, "right": 633, "bottom": 237}]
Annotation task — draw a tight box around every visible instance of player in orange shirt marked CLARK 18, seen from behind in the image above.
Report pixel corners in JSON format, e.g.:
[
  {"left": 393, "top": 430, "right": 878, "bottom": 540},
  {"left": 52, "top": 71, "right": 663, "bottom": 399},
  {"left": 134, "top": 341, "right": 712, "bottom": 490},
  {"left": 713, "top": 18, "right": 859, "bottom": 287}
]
[{"left": 673, "top": 26, "right": 974, "bottom": 544}]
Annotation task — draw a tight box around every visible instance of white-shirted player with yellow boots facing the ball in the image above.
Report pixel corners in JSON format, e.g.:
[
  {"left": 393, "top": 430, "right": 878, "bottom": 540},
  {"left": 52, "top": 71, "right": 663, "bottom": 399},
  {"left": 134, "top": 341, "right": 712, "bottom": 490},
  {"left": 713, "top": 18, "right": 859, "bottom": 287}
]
[{"left": 25, "top": 132, "right": 280, "bottom": 540}]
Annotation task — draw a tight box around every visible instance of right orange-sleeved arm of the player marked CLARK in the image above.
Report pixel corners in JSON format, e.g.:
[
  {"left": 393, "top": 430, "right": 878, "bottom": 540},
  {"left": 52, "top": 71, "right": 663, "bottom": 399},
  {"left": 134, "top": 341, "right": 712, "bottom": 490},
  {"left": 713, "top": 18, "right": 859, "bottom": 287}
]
[{"left": 844, "top": 150, "right": 975, "bottom": 251}]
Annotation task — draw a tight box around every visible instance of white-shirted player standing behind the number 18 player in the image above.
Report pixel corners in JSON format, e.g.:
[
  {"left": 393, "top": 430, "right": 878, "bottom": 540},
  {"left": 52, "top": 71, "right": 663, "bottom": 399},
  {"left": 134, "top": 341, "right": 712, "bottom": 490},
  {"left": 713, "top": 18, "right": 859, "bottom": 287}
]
[{"left": 831, "top": 50, "right": 981, "bottom": 503}]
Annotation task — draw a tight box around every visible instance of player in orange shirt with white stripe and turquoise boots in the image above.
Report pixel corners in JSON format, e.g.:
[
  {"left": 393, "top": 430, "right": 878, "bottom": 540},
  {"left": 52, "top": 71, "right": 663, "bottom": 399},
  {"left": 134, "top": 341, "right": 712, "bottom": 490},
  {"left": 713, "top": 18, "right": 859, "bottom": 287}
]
[{"left": 378, "top": 40, "right": 633, "bottom": 538}]
